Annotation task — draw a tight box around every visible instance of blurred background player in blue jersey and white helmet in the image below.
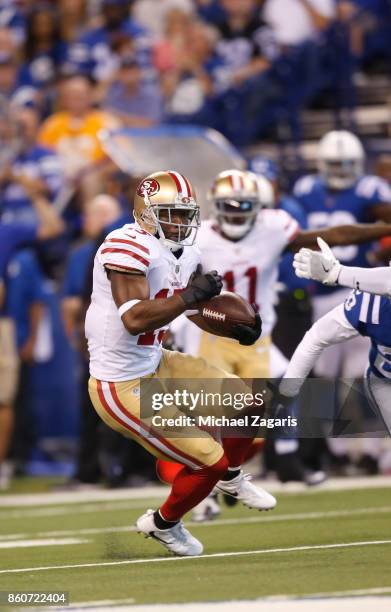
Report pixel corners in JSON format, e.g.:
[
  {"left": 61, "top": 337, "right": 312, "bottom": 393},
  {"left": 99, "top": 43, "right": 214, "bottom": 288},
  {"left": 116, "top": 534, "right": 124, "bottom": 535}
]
[{"left": 294, "top": 131, "right": 391, "bottom": 390}]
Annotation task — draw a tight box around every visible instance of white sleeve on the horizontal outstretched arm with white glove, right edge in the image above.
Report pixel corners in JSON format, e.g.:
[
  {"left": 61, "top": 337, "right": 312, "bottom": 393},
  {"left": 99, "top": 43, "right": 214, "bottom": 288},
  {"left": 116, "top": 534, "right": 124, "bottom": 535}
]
[{"left": 338, "top": 266, "right": 391, "bottom": 298}]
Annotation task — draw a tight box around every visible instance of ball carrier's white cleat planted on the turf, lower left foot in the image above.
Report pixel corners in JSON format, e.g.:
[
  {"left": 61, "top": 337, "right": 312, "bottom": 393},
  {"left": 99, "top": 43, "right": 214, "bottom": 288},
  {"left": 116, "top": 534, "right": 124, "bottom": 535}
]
[{"left": 136, "top": 510, "right": 204, "bottom": 557}]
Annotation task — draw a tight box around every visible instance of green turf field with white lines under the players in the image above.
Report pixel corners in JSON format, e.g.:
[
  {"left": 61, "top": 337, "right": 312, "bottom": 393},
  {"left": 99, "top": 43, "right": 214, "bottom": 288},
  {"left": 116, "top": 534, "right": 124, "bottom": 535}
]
[{"left": 0, "top": 482, "right": 391, "bottom": 603}]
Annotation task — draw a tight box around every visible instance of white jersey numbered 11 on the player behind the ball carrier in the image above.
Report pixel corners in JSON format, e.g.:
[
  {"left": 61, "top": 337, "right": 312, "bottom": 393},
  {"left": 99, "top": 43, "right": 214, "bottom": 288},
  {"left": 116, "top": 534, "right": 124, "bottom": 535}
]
[{"left": 197, "top": 209, "right": 300, "bottom": 336}]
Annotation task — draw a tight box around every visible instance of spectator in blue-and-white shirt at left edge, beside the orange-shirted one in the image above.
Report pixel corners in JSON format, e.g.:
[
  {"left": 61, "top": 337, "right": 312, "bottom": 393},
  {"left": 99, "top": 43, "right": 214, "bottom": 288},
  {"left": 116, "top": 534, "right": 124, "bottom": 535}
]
[{"left": 0, "top": 108, "right": 63, "bottom": 224}]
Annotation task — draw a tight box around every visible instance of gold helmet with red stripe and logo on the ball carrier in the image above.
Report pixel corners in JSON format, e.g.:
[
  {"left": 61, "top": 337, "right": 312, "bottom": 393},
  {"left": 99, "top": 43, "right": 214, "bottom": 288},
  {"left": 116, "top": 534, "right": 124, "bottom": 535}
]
[{"left": 134, "top": 170, "right": 200, "bottom": 251}]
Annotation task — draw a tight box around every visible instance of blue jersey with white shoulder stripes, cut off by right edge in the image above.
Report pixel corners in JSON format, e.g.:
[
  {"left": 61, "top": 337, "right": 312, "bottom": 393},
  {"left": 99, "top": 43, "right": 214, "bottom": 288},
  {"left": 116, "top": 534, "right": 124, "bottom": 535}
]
[{"left": 344, "top": 291, "right": 391, "bottom": 379}]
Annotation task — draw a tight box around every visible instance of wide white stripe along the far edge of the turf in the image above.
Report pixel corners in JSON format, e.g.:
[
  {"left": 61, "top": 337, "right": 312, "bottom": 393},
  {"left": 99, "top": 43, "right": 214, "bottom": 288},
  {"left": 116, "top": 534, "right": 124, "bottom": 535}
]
[{"left": 0, "top": 476, "right": 391, "bottom": 507}]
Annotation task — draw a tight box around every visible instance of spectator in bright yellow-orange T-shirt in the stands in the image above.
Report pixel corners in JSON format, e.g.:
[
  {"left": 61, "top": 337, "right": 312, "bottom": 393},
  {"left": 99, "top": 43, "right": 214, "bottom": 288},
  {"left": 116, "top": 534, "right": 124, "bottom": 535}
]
[{"left": 39, "top": 76, "right": 118, "bottom": 196}]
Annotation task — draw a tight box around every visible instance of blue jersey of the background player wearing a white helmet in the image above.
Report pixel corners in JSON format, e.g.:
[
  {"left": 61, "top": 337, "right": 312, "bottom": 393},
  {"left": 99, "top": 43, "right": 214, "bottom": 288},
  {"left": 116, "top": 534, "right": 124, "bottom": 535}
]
[{"left": 293, "top": 175, "right": 391, "bottom": 294}]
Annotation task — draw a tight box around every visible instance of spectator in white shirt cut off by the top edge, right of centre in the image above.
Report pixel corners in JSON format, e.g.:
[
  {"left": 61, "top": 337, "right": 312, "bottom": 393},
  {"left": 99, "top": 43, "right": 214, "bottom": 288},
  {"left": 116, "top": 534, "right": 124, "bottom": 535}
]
[{"left": 263, "top": 0, "right": 336, "bottom": 47}]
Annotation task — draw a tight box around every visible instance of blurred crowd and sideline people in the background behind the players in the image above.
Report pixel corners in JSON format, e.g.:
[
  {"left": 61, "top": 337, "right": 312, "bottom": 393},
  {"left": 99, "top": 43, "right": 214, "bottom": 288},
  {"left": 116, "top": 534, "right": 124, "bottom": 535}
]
[{"left": 0, "top": 0, "right": 391, "bottom": 486}]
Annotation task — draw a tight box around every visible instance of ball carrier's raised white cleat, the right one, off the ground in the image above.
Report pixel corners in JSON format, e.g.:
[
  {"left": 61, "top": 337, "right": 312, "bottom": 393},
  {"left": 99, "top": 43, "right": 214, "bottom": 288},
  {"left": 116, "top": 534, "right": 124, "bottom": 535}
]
[{"left": 216, "top": 471, "right": 277, "bottom": 510}]
